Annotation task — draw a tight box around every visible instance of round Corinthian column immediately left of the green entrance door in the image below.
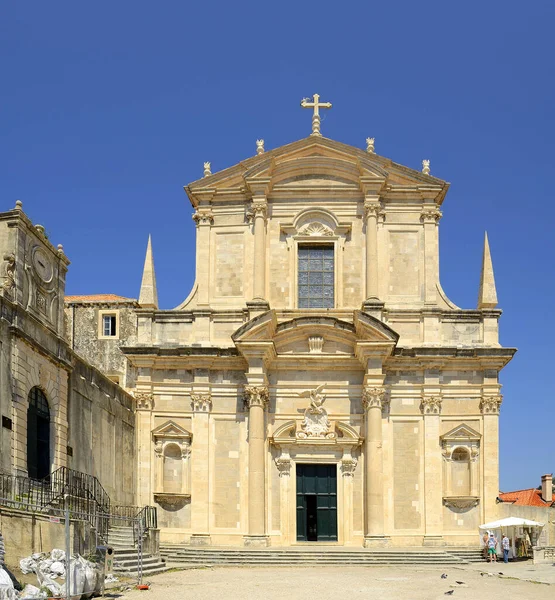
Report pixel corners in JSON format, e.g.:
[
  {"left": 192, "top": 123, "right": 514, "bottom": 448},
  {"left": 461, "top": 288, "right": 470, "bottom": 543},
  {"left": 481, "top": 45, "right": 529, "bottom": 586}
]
[{"left": 244, "top": 385, "right": 269, "bottom": 546}]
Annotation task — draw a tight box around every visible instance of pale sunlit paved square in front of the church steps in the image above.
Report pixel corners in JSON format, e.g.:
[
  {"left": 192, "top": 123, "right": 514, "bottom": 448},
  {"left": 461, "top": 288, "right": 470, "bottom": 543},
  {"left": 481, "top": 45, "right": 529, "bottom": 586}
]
[{"left": 124, "top": 564, "right": 555, "bottom": 600}]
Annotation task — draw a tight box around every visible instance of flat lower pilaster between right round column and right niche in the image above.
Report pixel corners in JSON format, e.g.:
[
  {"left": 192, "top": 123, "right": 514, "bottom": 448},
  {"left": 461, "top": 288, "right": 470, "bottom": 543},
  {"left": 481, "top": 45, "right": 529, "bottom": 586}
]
[{"left": 420, "top": 394, "right": 443, "bottom": 546}]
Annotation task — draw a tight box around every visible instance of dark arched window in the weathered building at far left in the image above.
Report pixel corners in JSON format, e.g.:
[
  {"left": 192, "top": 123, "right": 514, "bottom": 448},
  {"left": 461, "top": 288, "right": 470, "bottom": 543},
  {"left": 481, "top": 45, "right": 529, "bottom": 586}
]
[{"left": 27, "top": 387, "right": 50, "bottom": 479}]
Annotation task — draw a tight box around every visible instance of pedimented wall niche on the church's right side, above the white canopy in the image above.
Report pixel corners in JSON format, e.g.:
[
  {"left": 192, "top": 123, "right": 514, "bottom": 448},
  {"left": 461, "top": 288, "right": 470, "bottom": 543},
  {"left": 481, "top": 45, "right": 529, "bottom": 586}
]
[{"left": 441, "top": 424, "right": 481, "bottom": 512}]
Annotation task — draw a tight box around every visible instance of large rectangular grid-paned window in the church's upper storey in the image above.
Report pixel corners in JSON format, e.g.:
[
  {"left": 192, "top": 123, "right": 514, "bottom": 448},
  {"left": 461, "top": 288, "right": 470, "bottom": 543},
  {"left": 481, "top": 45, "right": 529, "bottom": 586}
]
[{"left": 297, "top": 245, "right": 334, "bottom": 308}]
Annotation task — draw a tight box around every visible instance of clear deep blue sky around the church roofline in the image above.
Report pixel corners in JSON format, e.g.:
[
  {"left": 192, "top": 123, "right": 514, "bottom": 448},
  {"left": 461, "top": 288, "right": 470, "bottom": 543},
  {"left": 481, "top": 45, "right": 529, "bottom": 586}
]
[{"left": 0, "top": 0, "right": 555, "bottom": 490}]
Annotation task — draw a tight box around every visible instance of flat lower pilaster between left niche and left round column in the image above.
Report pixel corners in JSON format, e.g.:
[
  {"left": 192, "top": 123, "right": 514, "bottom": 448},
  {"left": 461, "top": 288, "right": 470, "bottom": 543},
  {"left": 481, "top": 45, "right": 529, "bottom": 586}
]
[{"left": 191, "top": 392, "right": 212, "bottom": 546}]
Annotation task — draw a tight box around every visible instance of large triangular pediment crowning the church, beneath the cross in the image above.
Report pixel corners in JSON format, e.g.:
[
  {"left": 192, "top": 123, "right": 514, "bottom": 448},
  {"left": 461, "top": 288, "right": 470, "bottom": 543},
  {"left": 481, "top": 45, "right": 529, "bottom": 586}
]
[{"left": 185, "top": 136, "right": 448, "bottom": 205}]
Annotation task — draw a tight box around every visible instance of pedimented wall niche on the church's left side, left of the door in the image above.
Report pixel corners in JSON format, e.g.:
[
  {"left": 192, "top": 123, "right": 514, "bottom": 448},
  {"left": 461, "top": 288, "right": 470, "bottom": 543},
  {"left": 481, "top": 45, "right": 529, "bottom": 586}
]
[{"left": 152, "top": 421, "right": 192, "bottom": 510}]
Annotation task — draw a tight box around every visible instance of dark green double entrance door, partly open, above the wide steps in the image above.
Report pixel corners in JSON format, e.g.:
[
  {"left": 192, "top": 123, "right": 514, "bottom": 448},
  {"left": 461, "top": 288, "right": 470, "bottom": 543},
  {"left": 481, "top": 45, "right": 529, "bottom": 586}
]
[{"left": 297, "top": 465, "right": 337, "bottom": 542}]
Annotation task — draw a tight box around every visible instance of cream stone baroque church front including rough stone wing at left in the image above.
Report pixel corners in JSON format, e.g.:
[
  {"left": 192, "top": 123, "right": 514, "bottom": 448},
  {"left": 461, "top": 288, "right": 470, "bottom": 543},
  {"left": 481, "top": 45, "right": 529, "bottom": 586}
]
[{"left": 66, "top": 103, "right": 515, "bottom": 547}]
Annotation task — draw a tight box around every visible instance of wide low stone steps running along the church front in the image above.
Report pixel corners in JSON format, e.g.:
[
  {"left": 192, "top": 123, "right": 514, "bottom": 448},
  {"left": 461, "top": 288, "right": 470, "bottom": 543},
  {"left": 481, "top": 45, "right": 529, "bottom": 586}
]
[{"left": 160, "top": 544, "right": 483, "bottom": 567}]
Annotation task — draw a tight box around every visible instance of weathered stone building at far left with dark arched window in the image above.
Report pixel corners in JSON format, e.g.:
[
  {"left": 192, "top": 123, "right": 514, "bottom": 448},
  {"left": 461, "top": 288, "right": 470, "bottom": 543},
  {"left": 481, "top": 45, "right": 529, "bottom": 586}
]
[{"left": 0, "top": 201, "right": 137, "bottom": 505}]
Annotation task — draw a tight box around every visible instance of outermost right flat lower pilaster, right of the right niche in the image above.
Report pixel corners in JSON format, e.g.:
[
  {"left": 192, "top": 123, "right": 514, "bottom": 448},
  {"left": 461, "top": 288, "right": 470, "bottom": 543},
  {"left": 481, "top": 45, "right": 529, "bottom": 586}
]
[{"left": 480, "top": 394, "right": 503, "bottom": 523}]
